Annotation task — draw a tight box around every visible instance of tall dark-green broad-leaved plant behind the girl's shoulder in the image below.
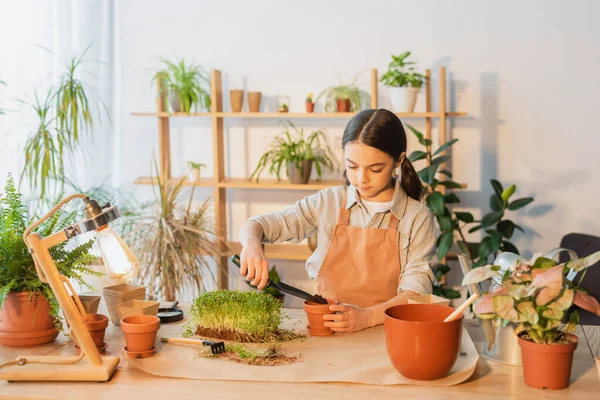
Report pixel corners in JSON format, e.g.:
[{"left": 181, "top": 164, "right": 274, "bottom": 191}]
[{"left": 406, "top": 124, "right": 533, "bottom": 299}]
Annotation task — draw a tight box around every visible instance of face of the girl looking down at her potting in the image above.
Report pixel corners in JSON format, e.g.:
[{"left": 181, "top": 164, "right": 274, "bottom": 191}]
[{"left": 344, "top": 142, "right": 404, "bottom": 201}]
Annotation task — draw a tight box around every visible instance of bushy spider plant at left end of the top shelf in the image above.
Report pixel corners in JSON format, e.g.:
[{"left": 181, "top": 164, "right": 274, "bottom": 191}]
[{"left": 152, "top": 59, "right": 211, "bottom": 113}]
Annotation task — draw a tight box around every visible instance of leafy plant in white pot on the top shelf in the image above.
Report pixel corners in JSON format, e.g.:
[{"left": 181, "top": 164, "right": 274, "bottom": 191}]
[{"left": 381, "top": 51, "right": 426, "bottom": 113}]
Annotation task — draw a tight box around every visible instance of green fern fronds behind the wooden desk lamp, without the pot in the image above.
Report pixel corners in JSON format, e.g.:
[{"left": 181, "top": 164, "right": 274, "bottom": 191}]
[{"left": 0, "top": 174, "right": 102, "bottom": 325}]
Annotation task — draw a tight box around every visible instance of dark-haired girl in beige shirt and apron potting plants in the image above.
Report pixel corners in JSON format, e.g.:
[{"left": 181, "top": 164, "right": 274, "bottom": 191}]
[{"left": 240, "top": 109, "right": 437, "bottom": 332}]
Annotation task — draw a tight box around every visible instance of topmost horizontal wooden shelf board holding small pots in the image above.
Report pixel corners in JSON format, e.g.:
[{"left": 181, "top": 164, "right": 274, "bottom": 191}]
[{"left": 131, "top": 111, "right": 467, "bottom": 119}]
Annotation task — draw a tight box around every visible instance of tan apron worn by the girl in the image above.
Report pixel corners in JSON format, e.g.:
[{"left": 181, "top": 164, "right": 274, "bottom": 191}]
[{"left": 316, "top": 197, "right": 400, "bottom": 307}]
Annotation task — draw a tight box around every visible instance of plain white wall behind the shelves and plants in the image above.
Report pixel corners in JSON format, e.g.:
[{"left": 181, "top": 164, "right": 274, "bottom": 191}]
[{"left": 0, "top": 0, "right": 600, "bottom": 304}]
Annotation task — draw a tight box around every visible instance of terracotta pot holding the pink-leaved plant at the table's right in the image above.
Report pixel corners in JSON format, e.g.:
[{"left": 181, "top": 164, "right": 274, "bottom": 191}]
[{"left": 518, "top": 335, "right": 577, "bottom": 390}]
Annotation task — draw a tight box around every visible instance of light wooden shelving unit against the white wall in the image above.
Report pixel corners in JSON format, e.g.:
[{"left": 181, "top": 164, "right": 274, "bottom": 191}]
[{"left": 132, "top": 67, "right": 467, "bottom": 288}]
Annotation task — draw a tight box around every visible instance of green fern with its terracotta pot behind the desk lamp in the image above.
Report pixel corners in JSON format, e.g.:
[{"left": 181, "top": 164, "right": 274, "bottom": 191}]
[{"left": 0, "top": 175, "right": 101, "bottom": 346}]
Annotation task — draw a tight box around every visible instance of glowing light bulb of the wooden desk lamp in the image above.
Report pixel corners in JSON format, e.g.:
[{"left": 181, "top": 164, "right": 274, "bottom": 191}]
[{"left": 96, "top": 227, "right": 140, "bottom": 282}]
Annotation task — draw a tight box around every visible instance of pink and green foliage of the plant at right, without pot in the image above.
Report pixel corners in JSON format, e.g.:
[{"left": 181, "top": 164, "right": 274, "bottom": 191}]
[{"left": 463, "top": 252, "right": 600, "bottom": 344}]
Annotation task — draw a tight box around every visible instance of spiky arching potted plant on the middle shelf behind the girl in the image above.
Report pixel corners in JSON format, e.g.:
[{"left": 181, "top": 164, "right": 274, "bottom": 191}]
[{"left": 250, "top": 121, "right": 334, "bottom": 184}]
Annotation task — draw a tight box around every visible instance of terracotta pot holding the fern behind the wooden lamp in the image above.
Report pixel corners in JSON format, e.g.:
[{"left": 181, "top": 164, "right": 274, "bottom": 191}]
[{"left": 0, "top": 292, "right": 58, "bottom": 347}]
